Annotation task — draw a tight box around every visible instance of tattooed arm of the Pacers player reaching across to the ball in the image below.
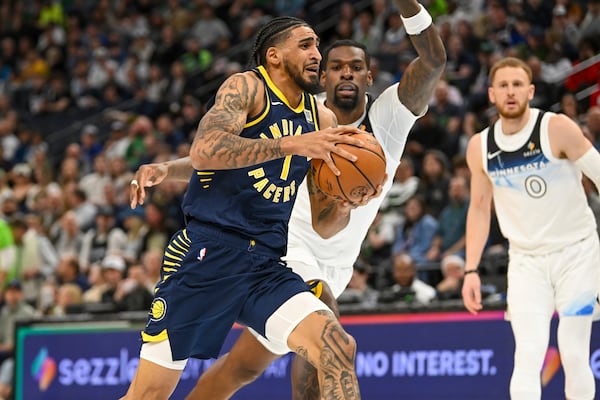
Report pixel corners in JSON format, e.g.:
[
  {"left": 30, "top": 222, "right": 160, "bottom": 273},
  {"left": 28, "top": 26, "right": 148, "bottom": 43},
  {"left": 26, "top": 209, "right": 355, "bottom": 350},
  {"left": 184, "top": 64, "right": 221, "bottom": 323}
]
[{"left": 190, "top": 71, "right": 361, "bottom": 173}]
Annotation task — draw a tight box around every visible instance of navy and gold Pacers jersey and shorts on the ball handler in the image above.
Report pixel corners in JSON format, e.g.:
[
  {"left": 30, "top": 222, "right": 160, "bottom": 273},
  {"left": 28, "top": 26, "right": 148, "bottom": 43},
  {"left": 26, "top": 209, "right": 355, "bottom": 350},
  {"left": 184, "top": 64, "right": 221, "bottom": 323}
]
[{"left": 142, "top": 67, "right": 318, "bottom": 360}]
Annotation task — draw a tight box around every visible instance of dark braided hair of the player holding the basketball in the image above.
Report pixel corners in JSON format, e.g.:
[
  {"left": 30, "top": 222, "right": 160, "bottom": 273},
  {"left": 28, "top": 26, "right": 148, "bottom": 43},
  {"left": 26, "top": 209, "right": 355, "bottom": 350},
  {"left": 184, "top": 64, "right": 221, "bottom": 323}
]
[{"left": 250, "top": 17, "right": 311, "bottom": 65}]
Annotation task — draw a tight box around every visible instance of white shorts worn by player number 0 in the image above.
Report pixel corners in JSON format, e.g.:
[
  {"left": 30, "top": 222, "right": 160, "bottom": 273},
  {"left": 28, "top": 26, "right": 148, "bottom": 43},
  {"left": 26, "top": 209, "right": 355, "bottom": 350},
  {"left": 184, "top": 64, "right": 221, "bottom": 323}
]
[{"left": 506, "top": 235, "right": 600, "bottom": 318}]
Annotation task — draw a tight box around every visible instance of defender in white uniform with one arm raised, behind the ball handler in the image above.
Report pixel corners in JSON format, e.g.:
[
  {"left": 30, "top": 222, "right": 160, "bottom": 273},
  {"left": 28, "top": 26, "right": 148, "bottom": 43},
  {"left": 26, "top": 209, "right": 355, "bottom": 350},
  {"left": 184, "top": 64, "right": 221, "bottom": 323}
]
[{"left": 127, "top": 0, "right": 446, "bottom": 400}]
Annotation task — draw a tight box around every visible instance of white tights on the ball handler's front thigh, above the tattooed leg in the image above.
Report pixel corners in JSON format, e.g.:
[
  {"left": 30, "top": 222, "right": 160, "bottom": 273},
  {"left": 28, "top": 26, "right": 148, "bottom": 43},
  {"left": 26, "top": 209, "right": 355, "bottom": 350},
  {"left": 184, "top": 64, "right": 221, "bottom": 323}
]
[{"left": 248, "top": 292, "right": 333, "bottom": 355}]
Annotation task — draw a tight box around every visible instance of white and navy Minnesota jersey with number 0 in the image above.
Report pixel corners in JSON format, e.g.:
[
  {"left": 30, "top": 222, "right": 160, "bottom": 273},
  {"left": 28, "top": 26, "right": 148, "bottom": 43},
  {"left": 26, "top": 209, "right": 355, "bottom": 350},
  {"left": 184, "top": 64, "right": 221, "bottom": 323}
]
[{"left": 481, "top": 109, "right": 596, "bottom": 254}]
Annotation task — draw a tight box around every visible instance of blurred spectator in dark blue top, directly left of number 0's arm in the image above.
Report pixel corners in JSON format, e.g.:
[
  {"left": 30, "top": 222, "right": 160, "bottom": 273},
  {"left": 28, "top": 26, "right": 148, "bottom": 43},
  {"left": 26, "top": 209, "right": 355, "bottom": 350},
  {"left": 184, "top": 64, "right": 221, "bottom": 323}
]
[{"left": 427, "top": 176, "right": 469, "bottom": 261}]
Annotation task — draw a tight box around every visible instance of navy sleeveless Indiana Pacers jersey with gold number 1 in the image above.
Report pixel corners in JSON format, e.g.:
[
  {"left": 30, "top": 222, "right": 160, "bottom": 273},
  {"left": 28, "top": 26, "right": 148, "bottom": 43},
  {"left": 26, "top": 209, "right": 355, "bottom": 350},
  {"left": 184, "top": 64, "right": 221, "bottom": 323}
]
[{"left": 182, "top": 67, "right": 318, "bottom": 255}]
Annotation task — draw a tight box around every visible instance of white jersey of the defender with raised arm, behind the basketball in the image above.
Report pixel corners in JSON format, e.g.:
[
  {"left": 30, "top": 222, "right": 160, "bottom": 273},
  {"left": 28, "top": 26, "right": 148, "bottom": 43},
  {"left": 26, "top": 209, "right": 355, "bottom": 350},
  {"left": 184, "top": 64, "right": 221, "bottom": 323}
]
[{"left": 284, "top": 84, "right": 426, "bottom": 297}]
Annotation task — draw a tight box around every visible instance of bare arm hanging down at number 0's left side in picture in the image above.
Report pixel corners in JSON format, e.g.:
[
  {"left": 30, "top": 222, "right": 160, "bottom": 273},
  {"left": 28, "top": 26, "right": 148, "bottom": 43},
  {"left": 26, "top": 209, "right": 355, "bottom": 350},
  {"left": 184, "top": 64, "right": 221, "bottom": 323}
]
[{"left": 462, "top": 134, "right": 492, "bottom": 314}]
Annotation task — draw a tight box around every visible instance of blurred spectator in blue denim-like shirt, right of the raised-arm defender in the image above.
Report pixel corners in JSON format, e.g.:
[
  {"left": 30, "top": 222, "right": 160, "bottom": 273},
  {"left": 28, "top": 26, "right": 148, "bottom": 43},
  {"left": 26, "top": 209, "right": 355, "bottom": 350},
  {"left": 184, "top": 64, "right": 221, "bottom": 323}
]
[{"left": 392, "top": 196, "right": 438, "bottom": 264}]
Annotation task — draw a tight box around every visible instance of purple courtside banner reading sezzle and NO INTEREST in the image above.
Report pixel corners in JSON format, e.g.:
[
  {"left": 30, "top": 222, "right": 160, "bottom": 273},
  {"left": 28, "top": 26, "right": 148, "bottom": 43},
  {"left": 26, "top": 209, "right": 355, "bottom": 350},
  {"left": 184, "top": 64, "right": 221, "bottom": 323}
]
[{"left": 15, "top": 311, "right": 600, "bottom": 400}]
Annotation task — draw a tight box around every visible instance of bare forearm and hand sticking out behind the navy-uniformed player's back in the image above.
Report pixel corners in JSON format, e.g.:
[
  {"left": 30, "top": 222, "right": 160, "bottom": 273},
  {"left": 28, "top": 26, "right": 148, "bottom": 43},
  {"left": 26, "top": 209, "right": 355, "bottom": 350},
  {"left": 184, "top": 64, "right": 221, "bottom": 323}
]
[{"left": 129, "top": 157, "right": 194, "bottom": 208}]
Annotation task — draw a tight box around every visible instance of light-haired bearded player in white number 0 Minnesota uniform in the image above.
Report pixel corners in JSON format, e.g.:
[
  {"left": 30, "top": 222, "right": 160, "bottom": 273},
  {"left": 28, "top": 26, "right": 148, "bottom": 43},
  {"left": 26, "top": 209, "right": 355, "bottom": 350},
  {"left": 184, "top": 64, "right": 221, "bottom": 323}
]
[{"left": 462, "top": 58, "right": 600, "bottom": 400}]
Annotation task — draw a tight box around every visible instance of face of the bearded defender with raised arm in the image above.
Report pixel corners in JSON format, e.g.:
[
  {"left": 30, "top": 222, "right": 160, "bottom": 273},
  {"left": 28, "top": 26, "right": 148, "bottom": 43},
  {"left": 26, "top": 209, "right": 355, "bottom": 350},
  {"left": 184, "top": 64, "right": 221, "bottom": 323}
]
[{"left": 321, "top": 46, "right": 373, "bottom": 110}]
